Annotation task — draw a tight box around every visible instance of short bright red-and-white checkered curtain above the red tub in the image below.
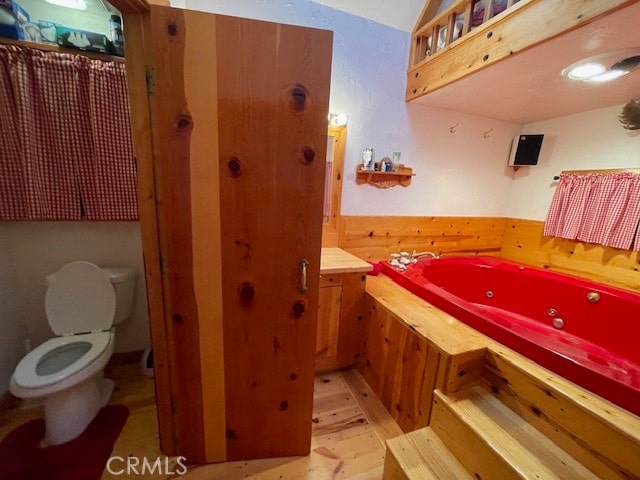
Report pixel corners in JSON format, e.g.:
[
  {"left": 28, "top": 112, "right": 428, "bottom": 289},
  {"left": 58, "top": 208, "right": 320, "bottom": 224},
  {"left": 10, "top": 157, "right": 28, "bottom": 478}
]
[{"left": 544, "top": 173, "right": 640, "bottom": 250}]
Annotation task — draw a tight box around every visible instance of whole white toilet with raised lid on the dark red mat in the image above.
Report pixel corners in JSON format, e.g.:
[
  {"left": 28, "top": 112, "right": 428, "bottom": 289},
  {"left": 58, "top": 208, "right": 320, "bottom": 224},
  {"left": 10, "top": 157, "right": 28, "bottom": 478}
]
[{"left": 10, "top": 262, "right": 135, "bottom": 445}]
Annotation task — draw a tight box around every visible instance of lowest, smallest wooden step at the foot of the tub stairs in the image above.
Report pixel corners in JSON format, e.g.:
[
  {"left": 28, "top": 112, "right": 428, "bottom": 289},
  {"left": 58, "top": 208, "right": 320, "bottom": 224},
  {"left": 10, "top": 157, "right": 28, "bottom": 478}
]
[{"left": 382, "top": 427, "right": 473, "bottom": 480}]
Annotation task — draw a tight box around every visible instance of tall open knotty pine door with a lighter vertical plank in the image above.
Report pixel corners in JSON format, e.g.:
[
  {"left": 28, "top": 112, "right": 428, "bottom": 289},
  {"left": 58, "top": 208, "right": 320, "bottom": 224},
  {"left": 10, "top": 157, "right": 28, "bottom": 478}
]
[{"left": 125, "top": 5, "right": 332, "bottom": 463}]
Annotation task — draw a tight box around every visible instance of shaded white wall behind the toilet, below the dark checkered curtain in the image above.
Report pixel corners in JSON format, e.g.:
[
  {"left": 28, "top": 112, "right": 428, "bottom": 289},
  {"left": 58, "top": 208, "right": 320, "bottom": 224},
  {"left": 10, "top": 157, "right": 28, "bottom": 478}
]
[{"left": 0, "top": 222, "right": 150, "bottom": 392}]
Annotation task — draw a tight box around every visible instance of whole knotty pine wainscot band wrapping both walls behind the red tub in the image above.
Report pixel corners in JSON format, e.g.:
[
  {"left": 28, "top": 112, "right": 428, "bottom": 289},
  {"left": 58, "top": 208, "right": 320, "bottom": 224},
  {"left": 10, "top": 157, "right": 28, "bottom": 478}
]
[{"left": 339, "top": 216, "right": 640, "bottom": 291}]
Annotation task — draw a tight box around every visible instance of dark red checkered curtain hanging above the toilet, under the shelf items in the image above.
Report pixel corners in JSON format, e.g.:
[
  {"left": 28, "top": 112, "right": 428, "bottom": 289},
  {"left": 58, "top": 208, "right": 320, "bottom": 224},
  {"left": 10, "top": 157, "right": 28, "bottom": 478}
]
[{"left": 0, "top": 45, "right": 138, "bottom": 220}]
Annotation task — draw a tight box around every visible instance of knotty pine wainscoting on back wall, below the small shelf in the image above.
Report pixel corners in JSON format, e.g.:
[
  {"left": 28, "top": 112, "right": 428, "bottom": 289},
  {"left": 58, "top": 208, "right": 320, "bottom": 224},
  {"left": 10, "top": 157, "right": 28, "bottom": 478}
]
[{"left": 339, "top": 216, "right": 505, "bottom": 260}]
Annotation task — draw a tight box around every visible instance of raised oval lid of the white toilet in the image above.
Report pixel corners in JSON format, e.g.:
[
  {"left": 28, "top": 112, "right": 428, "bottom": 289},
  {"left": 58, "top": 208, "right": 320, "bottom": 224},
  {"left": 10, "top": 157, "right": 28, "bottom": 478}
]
[{"left": 44, "top": 262, "right": 116, "bottom": 335}]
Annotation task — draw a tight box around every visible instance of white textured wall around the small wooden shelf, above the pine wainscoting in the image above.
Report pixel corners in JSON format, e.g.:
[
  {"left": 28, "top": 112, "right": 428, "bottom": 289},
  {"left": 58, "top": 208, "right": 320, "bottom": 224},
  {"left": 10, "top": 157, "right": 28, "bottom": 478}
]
[{"left": 182, "top": 0, "right": 521, "bottom": 216}]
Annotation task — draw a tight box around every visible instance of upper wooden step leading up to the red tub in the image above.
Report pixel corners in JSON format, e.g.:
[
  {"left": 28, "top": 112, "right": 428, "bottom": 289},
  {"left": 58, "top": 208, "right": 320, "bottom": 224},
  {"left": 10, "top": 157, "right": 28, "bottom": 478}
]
[{"left": 430, "top": 385, "right": 598, "bottom": 480}]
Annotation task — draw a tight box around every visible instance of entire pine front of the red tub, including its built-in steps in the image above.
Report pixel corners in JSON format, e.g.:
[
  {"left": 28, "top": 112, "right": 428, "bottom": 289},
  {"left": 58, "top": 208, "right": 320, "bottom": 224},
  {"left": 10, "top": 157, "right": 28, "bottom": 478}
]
[{"left": 358, "top": 276, "right": 640, "bottom": 480}]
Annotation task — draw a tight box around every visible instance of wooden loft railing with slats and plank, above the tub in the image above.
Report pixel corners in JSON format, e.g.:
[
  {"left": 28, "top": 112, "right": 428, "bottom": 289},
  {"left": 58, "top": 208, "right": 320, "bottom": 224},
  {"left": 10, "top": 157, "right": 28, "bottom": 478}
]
[{"left": 406, "top": 0, "right": 637, "bottom": 101}]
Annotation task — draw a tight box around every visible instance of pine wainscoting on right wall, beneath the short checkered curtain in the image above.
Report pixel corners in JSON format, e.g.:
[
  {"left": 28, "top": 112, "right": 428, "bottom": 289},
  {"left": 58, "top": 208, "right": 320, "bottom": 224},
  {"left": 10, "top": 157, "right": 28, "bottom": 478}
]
[{"left": 500, "top": 218, "right": 640, "bottom": 291}]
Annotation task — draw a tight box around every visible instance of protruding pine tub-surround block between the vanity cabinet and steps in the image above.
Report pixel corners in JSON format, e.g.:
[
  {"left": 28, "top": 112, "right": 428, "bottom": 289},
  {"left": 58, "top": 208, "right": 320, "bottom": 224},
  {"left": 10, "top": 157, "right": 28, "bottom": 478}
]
[{"left": 358, "top": 275, "right": 487, "bottom": 432}]
